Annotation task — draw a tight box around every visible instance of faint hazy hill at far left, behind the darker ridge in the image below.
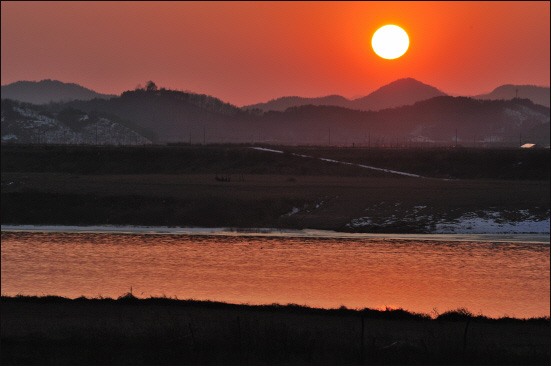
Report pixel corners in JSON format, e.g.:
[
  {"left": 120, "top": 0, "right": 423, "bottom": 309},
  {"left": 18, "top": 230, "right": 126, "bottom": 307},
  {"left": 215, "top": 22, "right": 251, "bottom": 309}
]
[{"left": 1, "top": 79, "right": 115, "bottom": 104}]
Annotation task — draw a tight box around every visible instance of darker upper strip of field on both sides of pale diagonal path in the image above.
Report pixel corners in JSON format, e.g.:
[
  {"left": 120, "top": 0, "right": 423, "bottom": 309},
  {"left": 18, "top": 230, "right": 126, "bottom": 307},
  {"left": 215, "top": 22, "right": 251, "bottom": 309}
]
[{"left": 1, "top": 145, "right": 551, "bottom": 180}]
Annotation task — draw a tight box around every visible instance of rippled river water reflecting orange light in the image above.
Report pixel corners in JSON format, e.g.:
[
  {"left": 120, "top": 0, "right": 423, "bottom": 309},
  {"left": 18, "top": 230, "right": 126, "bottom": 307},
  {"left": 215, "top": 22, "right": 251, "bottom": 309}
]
[{"left": 1, "top": 232, "right": 550, "bottom": 317}]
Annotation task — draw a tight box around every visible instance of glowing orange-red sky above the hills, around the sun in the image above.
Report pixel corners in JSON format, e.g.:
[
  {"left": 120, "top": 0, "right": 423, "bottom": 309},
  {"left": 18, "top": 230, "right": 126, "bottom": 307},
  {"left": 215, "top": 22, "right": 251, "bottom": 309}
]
[{"left": 1, "top": 1, "right": 550, "bottom": 106}]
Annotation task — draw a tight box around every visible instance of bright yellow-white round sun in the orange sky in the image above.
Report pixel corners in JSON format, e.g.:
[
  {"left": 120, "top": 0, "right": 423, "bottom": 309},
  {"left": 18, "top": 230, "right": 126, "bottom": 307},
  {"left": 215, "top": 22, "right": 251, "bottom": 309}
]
[{"left": 371, "top": 25, "right": 409, "bottom": 60}]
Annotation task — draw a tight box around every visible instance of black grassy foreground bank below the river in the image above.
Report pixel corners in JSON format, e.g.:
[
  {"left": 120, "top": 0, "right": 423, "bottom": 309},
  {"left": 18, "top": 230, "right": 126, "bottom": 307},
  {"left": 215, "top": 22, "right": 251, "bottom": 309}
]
[{"left": 1, "top": 295, "right": 551, "bottom": 365}]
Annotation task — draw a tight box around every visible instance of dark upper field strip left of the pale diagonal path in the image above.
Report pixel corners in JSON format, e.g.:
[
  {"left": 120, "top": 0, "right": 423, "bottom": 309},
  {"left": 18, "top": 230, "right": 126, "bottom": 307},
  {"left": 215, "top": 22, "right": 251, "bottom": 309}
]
[{"left": 1, "top": 145, "right": 384, "bottom": 180}]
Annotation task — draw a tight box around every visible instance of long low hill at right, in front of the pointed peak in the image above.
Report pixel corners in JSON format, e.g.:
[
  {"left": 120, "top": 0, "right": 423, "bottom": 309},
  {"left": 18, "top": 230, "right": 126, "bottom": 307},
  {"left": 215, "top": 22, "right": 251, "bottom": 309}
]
[{"left": 264, "top": 96, "right": 550, "bottom": 147}]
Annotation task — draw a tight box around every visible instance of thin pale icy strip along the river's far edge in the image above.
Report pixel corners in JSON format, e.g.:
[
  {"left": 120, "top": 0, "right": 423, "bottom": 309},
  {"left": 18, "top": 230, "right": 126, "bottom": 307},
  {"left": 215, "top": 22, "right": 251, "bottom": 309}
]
[{"left": 1, "top": 225, "right": 551, "bottom": 245}]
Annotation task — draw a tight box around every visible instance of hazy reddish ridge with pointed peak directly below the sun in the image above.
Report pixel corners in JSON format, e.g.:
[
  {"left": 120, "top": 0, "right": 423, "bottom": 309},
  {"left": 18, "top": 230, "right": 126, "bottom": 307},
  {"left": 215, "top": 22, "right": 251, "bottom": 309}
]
[{"left": 243, "top": 78, "right": 446, "bottom": 111}]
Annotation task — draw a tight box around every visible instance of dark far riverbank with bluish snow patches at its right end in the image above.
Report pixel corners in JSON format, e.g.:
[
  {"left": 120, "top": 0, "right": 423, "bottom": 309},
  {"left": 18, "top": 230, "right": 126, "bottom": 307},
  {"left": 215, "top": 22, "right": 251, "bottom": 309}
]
[{"left": 1, "top": 173, "right": 550, "bottom": 234}]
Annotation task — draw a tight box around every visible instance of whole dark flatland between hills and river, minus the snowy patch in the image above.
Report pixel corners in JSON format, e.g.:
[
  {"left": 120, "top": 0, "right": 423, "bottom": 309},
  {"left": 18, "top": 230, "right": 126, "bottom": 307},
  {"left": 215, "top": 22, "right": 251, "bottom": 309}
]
[{"left": 1, "top": 146, "right": 550, "bottom": 233}]
